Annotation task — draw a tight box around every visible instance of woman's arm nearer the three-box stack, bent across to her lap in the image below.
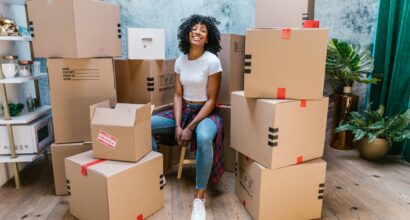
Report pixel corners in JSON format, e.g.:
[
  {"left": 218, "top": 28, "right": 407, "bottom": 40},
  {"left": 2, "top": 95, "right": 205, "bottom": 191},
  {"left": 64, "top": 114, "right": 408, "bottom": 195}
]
[{"left": 181, "top": 72, "right": 222, "bottom": 145}]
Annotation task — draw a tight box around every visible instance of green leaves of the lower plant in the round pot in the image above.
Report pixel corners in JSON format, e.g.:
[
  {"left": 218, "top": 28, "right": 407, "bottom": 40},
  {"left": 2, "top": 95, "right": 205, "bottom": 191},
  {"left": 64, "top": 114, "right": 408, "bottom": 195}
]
[{"left": 335, "top": 105, "right": 410, "bottom": 143}]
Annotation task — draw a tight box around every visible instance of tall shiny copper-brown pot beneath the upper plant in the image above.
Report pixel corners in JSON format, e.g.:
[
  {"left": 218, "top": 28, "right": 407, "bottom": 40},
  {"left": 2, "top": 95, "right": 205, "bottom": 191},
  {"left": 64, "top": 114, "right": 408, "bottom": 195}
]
[{"left": 330, "top": 86, "right": 359, "bottom": 150}]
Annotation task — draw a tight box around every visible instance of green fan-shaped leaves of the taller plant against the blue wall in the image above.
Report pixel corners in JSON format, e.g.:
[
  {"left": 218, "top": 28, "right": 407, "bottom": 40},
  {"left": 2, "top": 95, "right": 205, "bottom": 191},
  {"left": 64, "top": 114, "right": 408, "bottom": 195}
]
[{"left": 326, "top": 39, "right": 379, "bottom": 86}]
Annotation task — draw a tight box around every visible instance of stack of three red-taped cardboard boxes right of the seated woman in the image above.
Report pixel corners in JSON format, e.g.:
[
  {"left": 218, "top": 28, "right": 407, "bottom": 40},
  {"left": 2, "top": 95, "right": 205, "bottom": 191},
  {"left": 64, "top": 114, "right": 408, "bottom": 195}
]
[{"left": 231, "top": 1, "right": 328, "bottom": 219}]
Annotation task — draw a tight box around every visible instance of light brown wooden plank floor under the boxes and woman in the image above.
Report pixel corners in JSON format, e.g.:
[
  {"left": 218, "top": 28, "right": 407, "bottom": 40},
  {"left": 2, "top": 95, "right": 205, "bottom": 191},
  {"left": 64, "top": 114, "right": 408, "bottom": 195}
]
[{"left": 0, "top": 145, "right": 410, "bottom": 220}]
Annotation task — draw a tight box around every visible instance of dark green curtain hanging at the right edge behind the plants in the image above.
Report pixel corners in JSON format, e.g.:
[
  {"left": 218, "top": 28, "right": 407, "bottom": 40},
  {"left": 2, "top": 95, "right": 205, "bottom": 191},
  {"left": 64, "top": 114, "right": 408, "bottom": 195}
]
[{"left": 370, "top": 0, "right": 410, "bottom": 161}]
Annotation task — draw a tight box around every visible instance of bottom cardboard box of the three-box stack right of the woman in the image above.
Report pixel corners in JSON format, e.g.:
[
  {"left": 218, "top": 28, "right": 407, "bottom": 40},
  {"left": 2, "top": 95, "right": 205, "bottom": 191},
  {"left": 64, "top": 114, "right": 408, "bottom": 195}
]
[{"left": 235, "top": 155, "right": 326, "bottom": 219}]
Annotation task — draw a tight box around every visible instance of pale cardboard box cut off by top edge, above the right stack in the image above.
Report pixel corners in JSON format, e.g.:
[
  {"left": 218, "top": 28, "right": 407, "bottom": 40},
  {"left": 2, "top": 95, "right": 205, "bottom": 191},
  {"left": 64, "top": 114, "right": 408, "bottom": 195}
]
[{"left": 255, "top": 0, "right": 315, "bottom": 28}]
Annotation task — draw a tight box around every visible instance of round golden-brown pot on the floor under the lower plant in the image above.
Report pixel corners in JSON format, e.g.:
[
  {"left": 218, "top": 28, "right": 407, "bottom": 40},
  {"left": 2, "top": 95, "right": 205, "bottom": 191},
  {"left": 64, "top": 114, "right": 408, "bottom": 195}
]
[{"left": 357, "top": 138, "right": 391, "bottom": 160}]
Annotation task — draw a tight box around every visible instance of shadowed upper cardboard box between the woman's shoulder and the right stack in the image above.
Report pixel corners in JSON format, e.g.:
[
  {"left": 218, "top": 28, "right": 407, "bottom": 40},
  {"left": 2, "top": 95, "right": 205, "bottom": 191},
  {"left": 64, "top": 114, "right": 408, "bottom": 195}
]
[{"left": 217, "top": 34, "right": 245, "bottom": 105}]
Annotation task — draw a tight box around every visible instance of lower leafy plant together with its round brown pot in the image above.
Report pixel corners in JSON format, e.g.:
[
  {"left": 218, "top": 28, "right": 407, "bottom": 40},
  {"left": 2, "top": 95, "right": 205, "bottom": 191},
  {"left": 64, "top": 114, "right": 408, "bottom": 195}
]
[{"left": 335, "top": 105, "right": 410, "bottom": 160}]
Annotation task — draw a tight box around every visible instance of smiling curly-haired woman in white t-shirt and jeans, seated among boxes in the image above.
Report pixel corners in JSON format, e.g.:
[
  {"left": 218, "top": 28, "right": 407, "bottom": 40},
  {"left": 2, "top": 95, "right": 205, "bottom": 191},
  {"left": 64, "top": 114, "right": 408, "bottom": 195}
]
[{"left": 151, "top": 15, "right": 223, "bottom": 219}]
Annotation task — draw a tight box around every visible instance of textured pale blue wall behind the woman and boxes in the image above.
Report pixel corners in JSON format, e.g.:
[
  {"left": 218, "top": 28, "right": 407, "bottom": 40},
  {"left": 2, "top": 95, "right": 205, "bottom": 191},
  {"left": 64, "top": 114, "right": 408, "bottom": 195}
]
[{"left": 41, "top": 0, "right": 378, "bottom": 106}]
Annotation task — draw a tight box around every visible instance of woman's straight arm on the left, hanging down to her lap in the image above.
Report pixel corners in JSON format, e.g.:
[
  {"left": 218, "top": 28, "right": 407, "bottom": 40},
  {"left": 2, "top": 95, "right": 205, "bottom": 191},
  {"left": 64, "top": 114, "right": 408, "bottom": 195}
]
[{"left": 173, "top": 74, "right": 183, "bottom": 144}]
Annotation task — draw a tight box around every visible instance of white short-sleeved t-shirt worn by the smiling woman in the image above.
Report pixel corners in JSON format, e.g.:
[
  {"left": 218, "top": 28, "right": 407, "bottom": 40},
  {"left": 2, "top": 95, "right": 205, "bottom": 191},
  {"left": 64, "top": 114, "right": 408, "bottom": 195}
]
[{"left": 174, "top": 51, "right": 222, "bottom": 102}]
